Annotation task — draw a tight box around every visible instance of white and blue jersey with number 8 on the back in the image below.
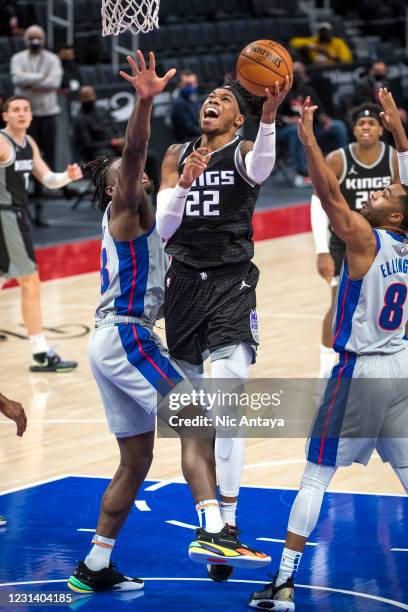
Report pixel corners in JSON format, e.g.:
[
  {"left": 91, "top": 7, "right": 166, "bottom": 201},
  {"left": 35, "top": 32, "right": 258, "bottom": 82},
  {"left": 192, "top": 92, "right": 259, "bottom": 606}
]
[{"left": 333, "top": 229, "right": 408, "bottom": 355}]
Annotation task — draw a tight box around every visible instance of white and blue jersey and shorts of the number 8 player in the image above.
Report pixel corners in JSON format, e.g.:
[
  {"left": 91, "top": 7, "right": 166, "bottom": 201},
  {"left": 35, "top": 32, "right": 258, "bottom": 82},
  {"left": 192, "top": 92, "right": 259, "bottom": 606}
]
[{"left": 307, "top": 230, "right": 408, "bottom": 467}]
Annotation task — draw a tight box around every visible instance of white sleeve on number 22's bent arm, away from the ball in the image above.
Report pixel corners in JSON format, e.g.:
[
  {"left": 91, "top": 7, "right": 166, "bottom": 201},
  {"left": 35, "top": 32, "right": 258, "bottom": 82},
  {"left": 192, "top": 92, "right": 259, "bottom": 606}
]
[{"left": 156, "top": 185, "right": 190, "bottom": 240}]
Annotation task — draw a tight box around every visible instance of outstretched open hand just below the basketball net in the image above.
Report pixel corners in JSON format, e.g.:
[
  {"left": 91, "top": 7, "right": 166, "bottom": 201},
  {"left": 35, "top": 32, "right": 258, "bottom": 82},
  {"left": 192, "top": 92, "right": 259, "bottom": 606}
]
[{"left": 119, "top": 51, "right": 176, "bottom": 99}]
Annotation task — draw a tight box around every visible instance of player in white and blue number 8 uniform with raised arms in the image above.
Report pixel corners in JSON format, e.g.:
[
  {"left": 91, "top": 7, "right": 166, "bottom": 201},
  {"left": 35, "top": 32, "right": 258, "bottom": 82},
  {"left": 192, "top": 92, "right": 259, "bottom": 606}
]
[{"left": 249, "top": 93, "right": 408, "bottom": 612}]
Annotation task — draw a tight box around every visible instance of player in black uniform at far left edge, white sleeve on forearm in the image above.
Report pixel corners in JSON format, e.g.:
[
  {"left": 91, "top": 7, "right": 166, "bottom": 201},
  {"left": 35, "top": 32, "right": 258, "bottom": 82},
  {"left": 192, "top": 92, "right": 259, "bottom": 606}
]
[{"left": 0, "top": 96, "right": 82, "bottom": 372}]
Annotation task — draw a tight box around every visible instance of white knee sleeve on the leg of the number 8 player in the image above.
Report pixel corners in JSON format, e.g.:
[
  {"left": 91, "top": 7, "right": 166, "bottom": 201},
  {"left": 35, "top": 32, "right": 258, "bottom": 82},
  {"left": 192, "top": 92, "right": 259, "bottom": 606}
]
[{"left": 288, "top": 461, "right": 336, "bottom": 538}]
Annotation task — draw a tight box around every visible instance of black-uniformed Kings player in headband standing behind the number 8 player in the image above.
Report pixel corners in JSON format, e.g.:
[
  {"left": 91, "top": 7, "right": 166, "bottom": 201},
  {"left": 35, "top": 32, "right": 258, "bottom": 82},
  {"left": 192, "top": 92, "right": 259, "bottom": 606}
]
[{"left": 311, "top": 103, "right": 400, "bottom": 378}]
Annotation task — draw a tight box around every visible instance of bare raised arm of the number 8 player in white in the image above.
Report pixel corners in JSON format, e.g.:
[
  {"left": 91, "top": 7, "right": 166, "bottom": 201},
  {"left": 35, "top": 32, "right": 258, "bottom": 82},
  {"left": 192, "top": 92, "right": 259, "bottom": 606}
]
[{"left": 299, "top": 98, "right": 375, "bottom": 254}]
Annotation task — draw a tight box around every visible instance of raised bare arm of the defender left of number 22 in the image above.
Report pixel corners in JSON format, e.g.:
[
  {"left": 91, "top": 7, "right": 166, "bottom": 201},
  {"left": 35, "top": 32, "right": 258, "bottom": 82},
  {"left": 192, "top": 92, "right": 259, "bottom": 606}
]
[{"left": 112, "top": 51, "right": 176, "bottom": 213}]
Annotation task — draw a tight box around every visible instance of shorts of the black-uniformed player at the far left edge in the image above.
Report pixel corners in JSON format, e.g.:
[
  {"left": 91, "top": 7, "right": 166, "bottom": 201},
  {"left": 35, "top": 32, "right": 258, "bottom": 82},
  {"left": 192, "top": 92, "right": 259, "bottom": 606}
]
[{"left": 0, "top": 206, "right": 37, "bottom": 279}]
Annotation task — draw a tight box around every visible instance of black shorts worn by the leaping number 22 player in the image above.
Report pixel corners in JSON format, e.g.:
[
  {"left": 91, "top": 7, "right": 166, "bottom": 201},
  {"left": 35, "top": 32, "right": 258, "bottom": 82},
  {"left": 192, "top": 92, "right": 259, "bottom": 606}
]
[{"left": 164, "top": 259, "right": 259, "bottom": 365}]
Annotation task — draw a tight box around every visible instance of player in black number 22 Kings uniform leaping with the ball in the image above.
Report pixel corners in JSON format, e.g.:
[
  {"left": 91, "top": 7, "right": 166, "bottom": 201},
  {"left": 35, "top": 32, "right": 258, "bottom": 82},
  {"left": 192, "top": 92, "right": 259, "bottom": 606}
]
[{"left": 157, "top": 77, "right": 292, "bottom": 581}]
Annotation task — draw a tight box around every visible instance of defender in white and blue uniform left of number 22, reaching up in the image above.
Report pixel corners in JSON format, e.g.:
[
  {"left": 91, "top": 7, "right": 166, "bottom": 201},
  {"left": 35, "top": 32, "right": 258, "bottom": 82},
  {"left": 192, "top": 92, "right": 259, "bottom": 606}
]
[{"left": 68, "top": 51, "right": 270, "bottom": 593}]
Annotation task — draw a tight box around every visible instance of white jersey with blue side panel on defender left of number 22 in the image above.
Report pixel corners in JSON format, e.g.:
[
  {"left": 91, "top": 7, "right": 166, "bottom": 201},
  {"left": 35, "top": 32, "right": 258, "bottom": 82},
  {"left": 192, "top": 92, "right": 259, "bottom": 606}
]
[{"left": 95, "top": 204, "right": 168, "bottom": 324}]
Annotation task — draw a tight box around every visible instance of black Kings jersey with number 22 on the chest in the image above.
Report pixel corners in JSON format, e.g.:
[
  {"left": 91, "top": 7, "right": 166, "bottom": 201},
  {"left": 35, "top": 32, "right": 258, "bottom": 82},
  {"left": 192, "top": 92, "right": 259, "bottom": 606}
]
[{"left": 166, "top": 136, "right": 260, "bottom": 270}]
